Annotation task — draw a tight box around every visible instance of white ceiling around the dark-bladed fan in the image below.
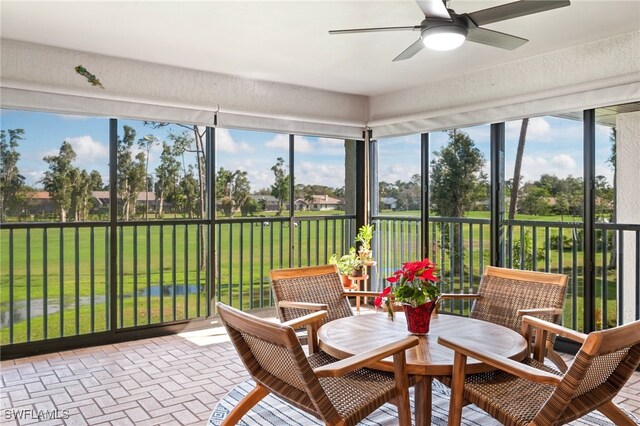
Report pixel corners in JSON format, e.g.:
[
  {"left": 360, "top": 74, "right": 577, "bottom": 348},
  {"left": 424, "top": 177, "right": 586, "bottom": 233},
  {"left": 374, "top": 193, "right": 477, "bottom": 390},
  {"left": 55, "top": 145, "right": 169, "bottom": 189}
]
[{"left": 0, "top": 0, "right": 640, "bottom": 95}]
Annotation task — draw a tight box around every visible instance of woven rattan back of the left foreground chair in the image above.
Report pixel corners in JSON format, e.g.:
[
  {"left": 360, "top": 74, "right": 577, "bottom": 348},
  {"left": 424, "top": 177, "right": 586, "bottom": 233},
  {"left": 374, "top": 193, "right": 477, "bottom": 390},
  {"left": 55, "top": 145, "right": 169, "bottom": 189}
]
[{"left": 217, "top": 304, "right": 338, "bottom": 422}]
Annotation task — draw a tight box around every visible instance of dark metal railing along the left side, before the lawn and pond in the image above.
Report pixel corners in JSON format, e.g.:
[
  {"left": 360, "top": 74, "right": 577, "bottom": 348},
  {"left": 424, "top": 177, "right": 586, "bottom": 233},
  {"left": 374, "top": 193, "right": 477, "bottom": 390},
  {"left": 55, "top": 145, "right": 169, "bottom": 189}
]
[{"left": 0, "top": 216, "right": 355, "bottom": 345}]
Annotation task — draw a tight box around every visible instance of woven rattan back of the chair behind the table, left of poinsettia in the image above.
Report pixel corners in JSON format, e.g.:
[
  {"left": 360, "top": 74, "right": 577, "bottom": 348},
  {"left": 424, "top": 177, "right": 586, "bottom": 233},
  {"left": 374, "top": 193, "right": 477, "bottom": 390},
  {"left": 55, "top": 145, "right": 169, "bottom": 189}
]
[{"left": 271, "top": 265, "right": 353, "bottom": 322}]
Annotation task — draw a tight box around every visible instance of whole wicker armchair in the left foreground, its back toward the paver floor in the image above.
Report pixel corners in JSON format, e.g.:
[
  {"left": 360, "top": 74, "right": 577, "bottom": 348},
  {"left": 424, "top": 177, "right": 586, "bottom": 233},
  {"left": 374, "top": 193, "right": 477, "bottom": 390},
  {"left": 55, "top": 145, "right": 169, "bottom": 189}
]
[{"left": 217, "top": 303, "right": 418, "bottom": 425}]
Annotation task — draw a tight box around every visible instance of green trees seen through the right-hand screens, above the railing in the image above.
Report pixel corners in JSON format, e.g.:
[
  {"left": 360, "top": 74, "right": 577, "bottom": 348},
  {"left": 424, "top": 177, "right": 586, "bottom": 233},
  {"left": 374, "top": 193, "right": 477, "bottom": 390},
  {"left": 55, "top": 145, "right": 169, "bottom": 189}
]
[{"left": 379, "top": 130, "right": 615, "bottom": 219}]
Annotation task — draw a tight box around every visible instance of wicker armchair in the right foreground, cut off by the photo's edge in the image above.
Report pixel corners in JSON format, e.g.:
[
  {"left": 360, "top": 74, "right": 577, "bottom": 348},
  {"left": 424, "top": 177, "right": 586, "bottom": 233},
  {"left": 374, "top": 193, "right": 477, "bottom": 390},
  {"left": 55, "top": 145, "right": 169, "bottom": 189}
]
[{"left": 438, "top": 316, "right": 640, "bottom": 426}]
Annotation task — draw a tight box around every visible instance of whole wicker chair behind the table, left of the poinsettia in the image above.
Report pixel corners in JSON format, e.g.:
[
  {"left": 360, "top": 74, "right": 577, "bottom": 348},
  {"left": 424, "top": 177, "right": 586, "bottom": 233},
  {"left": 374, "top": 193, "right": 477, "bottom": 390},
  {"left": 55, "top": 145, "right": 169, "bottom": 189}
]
[{"left": 271, "top": 265, "right": 379, "bottom": 353}]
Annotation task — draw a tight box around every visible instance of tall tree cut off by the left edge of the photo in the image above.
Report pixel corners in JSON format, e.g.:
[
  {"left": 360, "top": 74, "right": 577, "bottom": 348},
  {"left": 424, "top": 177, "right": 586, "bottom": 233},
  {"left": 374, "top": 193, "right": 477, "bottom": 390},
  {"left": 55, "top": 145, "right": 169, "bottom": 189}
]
[{"left": 0, "top": 129, "right": 25, "bottom": 221}]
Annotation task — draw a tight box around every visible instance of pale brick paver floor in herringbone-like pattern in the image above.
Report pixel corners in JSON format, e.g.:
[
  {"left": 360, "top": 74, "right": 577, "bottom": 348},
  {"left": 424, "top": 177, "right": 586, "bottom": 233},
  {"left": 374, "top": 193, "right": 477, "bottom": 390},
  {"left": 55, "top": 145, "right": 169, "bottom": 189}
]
[{"left": 0, "top": 312, "right": 640, "bottom": 426}]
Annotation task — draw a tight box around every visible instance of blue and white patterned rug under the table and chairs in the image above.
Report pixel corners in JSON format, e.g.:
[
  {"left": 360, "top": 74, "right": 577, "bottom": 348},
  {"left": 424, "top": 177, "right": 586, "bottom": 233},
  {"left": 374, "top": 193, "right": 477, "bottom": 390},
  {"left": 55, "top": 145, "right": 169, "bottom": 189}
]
[{"left": 208, "top": 380, "right": 640, "bottom": 426}]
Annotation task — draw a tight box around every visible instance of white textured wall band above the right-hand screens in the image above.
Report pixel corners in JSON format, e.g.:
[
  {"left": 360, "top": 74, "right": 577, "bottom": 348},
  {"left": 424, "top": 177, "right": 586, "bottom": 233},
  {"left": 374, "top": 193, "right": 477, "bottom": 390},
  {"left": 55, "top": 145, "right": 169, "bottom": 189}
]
[{"left": 368, "top": 31, "right": 640, "bottom": 137}]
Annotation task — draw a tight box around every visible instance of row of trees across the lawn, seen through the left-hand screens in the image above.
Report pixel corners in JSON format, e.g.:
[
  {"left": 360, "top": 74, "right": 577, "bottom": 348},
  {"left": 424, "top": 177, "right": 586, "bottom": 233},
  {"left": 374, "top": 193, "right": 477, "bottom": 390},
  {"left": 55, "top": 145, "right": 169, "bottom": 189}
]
[{"left": 0, "top": 126, "right": 344, "bottom": 222}]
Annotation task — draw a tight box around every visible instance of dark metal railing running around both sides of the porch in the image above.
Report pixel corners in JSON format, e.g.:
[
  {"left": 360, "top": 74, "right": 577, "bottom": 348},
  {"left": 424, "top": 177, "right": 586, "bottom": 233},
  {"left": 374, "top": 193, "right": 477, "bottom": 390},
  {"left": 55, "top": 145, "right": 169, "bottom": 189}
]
[{"left": 0, "top": 216, "right": 640, "bottom": 345}]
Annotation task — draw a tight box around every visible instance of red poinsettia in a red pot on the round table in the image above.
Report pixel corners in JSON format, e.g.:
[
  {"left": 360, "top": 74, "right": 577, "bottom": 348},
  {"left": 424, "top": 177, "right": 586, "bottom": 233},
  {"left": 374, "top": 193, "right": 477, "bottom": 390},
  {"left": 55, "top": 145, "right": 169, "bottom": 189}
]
[{"left": 374, "top": 258, "right": 440, "bottom": 335}]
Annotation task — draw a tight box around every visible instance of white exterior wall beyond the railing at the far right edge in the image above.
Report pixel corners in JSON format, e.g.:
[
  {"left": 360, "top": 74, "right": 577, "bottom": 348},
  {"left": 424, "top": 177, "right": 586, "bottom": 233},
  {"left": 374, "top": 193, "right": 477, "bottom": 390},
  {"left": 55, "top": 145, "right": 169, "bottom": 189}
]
[{"left": 616, "top": 112, "right": 640, "bottom": 324}]
